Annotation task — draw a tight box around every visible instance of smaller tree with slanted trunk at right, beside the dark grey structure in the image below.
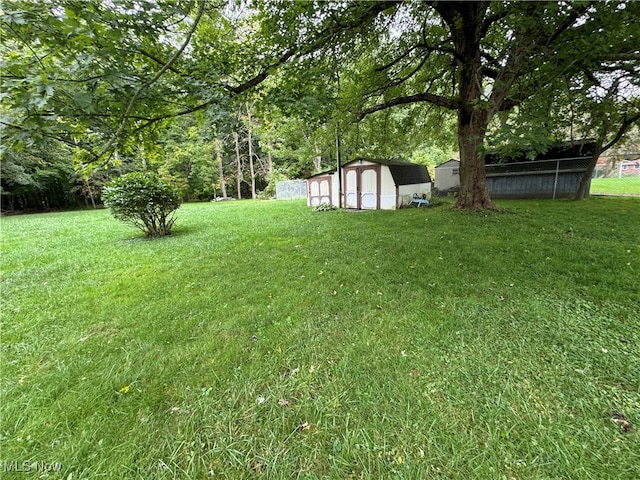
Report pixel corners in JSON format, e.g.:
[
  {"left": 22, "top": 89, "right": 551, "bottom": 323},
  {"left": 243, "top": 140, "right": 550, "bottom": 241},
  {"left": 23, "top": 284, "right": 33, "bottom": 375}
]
[{"left": 489, "top": 3, "right": 640, "bottom": 199}]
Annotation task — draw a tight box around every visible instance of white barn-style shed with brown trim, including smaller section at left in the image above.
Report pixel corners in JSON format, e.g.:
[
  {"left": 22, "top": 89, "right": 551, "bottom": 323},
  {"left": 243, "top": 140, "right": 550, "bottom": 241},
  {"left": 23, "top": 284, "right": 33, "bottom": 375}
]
[{"left": 307, "top": 158, "right": 431, "bottom": 210}]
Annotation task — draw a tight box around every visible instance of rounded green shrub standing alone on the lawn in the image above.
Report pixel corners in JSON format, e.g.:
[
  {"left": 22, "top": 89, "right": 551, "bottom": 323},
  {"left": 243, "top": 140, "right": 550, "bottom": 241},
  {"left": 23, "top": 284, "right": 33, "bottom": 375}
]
[{"left": 102, "top": 172, "right": 181, "bottom": 237}]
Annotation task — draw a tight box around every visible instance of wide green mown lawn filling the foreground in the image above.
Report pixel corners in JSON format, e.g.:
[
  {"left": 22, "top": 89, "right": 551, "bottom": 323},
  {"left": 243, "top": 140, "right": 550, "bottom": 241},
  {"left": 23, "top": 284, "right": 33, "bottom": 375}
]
[{"left": 0, "top": 198, "right": 640, "bottom": 480}]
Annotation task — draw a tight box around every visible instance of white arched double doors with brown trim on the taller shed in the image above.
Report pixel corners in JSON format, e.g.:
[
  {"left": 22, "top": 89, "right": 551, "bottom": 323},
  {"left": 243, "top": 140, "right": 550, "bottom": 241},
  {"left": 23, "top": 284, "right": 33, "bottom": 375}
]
[{"left": 344, "top": 165, "right": 380, "bottom": 210}]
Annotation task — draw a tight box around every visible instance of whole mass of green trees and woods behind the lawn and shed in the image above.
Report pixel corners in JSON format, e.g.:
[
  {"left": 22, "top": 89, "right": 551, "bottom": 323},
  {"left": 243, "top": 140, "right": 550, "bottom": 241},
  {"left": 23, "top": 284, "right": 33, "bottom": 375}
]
[{"left": 0, "top": 0, "right": 640, "bottom": 209}]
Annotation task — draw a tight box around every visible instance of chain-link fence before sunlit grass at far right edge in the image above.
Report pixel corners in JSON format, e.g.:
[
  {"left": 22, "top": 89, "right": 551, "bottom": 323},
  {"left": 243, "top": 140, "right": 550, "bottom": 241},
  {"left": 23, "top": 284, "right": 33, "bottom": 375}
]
[{"left": 591, "top": 154, "right": 640, "bottom": 196}]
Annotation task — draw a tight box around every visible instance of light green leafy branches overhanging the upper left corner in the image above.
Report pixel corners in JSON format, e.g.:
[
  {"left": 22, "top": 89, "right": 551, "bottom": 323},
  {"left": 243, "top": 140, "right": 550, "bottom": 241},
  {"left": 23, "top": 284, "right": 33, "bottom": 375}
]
[{"left": 2, "top": 0, "right": 235, "bottom": 161}]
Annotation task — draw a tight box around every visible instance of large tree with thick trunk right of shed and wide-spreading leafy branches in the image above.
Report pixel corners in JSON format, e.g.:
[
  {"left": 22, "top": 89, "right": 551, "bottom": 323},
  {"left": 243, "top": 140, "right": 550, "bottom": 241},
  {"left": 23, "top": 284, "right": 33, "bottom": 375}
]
[{"left": 2, "top": 0, "right": 640, "bottom": 209}]
